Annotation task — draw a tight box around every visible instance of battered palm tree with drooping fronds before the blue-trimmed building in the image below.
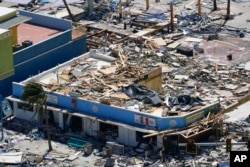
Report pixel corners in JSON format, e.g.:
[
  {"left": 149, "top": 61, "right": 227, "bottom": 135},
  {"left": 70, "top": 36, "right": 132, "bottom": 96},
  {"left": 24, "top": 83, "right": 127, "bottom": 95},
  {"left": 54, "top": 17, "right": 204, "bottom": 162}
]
[{"left": 21, "top": 81, "right": 52, "bottom": 151}]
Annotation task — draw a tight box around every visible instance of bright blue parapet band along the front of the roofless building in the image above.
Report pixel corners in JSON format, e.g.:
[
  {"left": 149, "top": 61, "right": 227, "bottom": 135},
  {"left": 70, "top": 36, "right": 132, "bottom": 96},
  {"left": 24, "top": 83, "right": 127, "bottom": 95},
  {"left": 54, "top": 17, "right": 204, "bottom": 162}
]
[{"left": 12, "top": 83, "right": 219, "bottom": 130}]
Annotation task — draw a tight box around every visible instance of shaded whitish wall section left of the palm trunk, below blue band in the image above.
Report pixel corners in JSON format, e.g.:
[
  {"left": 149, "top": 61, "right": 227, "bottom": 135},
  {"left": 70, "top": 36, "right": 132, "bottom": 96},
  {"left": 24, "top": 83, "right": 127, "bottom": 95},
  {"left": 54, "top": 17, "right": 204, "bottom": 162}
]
[{"left": 13, "top": 102, "right": 38, "bottom": 121}]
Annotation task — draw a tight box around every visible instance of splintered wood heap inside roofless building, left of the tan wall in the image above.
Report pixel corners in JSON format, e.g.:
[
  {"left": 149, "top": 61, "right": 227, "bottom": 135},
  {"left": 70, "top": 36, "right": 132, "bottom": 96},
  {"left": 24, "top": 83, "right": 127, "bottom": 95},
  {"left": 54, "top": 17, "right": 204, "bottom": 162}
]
[{"left": 41, "top": 52, "right": 146, "bottom": 106}]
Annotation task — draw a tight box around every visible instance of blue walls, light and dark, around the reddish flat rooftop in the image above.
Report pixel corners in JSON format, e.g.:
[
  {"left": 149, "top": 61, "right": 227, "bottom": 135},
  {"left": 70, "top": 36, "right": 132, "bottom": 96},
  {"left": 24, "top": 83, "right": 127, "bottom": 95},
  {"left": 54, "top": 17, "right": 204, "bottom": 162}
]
[{"left": 0, "top": 10, "right": 86, "bottom": 97}]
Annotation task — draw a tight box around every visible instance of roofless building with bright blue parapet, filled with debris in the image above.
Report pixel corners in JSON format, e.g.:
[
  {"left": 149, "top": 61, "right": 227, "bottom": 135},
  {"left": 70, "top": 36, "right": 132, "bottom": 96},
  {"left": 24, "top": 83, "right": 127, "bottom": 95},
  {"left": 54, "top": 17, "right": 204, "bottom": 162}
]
[{"left": 5, "top": 45, "right": 228, "bottom": 147}]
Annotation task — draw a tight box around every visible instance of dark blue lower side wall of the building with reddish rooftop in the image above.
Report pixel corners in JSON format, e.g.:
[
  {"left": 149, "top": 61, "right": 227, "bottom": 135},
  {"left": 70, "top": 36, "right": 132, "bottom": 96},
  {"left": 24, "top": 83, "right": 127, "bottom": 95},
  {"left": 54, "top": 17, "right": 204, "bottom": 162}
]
[{"left": 0, "top": 37, "right": 86, "bottom": 97}]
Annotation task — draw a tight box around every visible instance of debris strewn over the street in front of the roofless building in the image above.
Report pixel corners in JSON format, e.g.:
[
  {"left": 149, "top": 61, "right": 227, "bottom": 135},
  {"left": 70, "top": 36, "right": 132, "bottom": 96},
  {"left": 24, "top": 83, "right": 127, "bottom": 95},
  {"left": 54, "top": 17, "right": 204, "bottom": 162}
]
[{"left": 0, "top": 116, "right": 249, "bottom": 167}]
